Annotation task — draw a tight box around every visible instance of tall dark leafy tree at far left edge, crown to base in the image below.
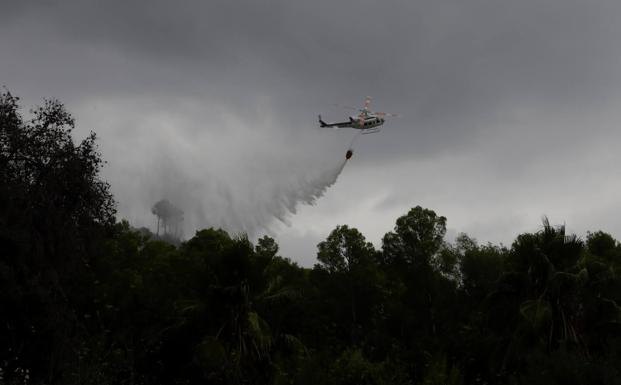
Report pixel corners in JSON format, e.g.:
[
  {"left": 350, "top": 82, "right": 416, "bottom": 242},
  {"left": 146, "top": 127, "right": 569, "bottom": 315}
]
[{"left": 0, "top": 91, "right": 116, "bottom": 382}]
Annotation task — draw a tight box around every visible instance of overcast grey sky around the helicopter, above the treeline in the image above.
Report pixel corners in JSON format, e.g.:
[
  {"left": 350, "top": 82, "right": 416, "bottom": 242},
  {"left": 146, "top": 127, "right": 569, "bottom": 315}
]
[{"left": 0, "top": 0, "right": 621, "bottom": 265}]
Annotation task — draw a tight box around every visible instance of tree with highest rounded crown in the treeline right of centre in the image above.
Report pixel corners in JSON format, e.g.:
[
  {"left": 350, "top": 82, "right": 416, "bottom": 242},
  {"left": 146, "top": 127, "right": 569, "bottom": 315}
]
[{"left": 381, "top": 206, "right": 456, "bottom": 377}]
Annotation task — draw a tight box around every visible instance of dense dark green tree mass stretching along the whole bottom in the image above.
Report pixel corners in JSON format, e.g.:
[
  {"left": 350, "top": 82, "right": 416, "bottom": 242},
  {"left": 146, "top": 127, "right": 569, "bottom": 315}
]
[{"left": 0, "top": 92, "right": 621, "bottom": 384}]
